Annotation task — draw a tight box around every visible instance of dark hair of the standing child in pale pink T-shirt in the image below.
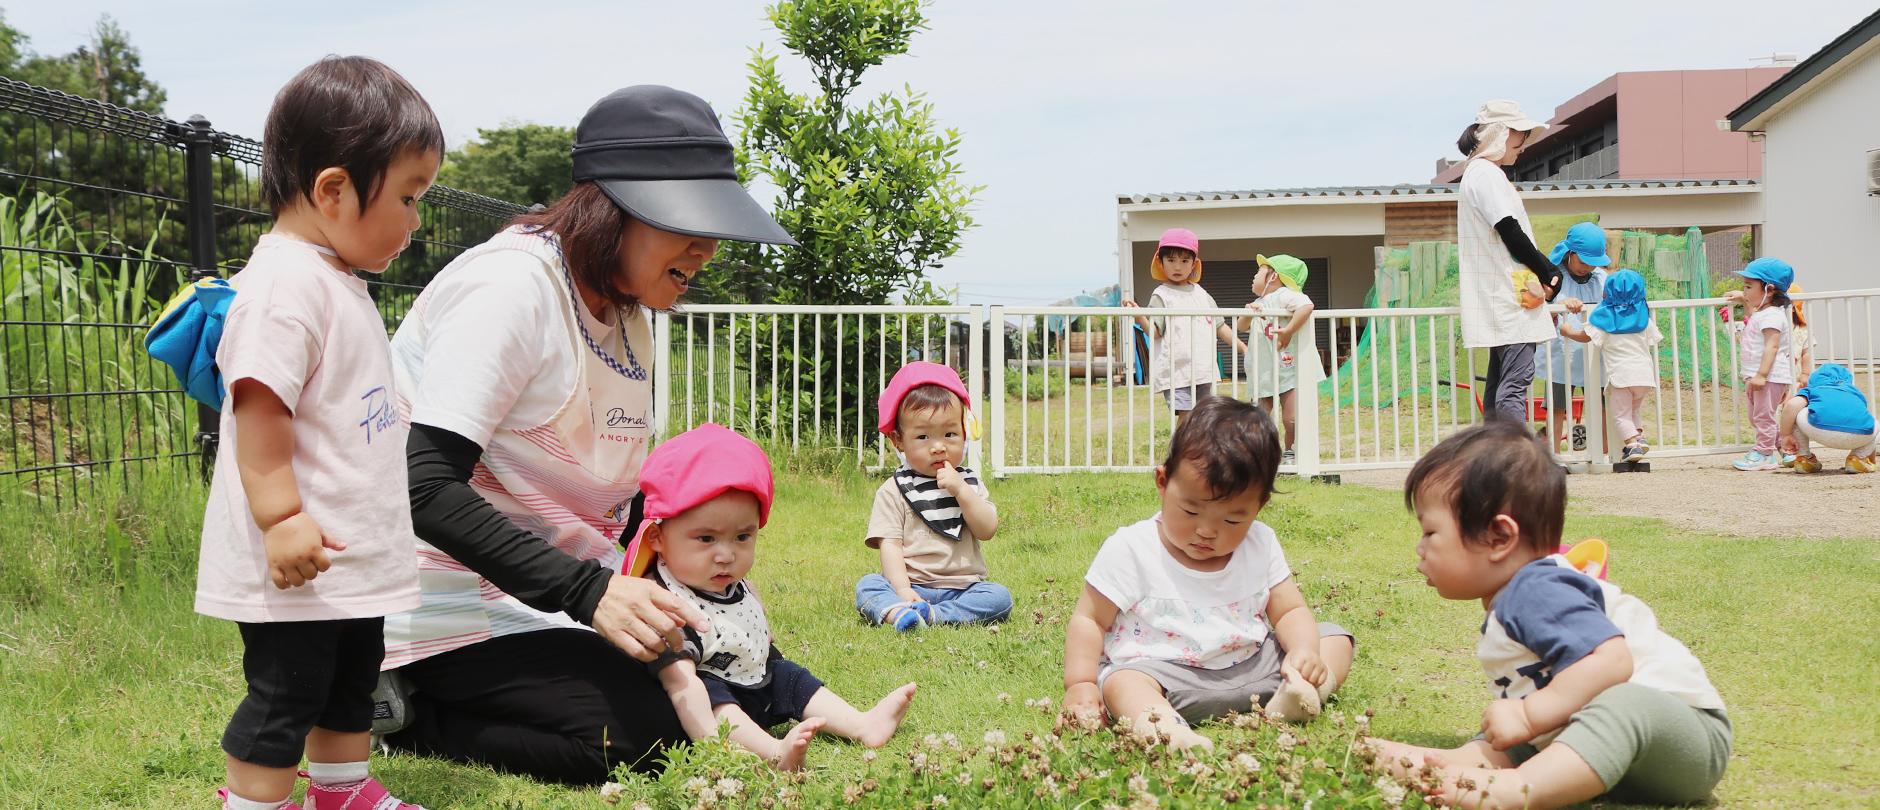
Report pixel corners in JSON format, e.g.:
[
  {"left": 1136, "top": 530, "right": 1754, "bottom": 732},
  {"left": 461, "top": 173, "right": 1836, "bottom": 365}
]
[{"left": 261, "top": 56, "right": 444, "bottom": 214}]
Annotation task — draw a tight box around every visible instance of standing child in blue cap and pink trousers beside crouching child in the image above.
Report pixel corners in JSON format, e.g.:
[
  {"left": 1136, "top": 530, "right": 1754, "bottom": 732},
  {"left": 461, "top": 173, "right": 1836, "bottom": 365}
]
[{"left": 1731, "top": 256, "right": 1795, "bottom": 472}]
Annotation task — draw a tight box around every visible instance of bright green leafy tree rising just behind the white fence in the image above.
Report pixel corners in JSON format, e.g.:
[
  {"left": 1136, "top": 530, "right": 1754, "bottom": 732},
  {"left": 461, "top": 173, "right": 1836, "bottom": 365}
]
[{"left": 703, "top": 0, "right": 979, "bottom": 304}]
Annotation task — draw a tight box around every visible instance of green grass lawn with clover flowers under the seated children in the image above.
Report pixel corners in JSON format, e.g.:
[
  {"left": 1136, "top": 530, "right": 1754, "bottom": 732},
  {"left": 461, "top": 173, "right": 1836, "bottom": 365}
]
[{"left": 0, "top": 455, "right": 1880, "bottom": 810}]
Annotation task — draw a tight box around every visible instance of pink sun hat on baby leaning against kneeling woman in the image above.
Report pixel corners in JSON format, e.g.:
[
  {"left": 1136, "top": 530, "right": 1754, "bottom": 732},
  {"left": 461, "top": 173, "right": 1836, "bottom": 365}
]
[{"left": 620, "top": 423, "right": 776, "bottom": 577}]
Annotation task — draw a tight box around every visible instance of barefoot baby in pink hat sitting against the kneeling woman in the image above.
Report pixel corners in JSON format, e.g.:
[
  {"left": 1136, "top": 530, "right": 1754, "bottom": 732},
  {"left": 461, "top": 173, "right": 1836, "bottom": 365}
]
[{"left": 628, "top": 425, "right": 916, "bottom": 771}]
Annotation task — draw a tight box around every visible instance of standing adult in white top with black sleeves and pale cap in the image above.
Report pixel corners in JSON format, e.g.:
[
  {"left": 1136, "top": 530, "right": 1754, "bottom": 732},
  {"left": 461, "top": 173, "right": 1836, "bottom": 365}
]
[{"left": 1455, "top": 100, "right": 1560, "bottom": 423}]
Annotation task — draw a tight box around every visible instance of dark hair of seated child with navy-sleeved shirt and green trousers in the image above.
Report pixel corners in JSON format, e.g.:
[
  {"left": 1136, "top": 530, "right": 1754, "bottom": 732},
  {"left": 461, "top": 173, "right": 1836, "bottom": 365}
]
[{"left": 1404, "top": 419, "right": 1566, "bottom": 554}]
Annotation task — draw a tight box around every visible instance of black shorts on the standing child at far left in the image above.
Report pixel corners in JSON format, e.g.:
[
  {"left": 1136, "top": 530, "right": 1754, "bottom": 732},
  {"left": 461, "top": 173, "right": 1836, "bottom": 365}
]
[{"left": 222, "top": 616, "right": 385, "bottom": 769}]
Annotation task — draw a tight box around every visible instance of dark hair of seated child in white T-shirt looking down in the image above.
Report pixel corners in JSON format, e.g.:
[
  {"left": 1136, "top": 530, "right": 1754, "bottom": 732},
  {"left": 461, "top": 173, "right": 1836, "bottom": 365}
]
[{"left": 1162, "top": 397, "right": 1280, "bottom": 504}]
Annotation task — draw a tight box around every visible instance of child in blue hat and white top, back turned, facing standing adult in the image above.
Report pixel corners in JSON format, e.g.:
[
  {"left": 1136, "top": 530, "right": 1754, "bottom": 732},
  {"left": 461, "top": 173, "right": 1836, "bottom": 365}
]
[{"left": 1560, "top": 272, "right": 1664, "bottom": 460}]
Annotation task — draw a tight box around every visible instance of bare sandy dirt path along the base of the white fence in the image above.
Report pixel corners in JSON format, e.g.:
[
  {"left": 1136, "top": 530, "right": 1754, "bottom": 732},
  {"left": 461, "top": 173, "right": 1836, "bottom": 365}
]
[{"left": 1342, "top": 453, "right": 1880, "bottom": 539}]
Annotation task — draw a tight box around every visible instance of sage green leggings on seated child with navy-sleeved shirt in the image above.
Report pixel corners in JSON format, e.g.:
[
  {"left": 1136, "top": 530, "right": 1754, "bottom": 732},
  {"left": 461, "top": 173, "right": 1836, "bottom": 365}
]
[{"left": 1508, "top": 684, "right": 1731, "bottom": 804}]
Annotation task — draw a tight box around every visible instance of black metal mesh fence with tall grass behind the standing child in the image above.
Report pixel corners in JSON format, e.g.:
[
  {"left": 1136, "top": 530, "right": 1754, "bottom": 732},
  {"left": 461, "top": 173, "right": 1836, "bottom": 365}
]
[{"left": 0, "top": 79, "right": 525, "bottom": 500}]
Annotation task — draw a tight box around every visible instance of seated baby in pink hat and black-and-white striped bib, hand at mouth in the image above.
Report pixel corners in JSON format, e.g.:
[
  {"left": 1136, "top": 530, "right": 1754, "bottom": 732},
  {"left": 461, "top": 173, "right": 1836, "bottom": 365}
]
[{"left": 855, "top": 363, "right": 1011, "bottom": 631}]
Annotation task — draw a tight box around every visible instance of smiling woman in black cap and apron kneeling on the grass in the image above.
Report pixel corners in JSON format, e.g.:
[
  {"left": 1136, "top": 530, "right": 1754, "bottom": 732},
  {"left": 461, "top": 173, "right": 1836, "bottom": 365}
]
[{"left": 380, "top": 86, "right": 795, "bottom": 782}]
